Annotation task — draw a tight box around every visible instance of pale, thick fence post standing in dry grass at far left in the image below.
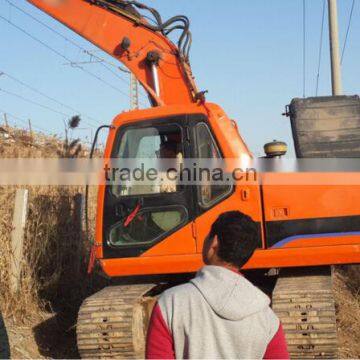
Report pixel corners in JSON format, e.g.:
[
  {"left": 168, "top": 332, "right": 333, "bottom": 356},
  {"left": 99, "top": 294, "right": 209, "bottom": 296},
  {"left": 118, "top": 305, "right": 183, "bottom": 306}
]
[{"left": 10, "top": 189, "right": 29, "bottom": 294}]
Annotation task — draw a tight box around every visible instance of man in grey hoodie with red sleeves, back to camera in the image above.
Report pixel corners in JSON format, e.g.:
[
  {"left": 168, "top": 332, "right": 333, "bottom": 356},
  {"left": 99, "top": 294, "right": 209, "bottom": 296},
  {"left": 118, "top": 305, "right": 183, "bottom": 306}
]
[{"left": 146, "top": 211, "right": 289, "bottom": 359}]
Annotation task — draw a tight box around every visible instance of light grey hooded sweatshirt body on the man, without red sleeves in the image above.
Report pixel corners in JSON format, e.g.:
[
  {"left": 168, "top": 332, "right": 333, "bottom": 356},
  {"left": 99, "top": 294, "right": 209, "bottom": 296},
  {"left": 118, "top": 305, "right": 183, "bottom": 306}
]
[{"left": 158, "top": 266, "right": 280, "bottom": 359}]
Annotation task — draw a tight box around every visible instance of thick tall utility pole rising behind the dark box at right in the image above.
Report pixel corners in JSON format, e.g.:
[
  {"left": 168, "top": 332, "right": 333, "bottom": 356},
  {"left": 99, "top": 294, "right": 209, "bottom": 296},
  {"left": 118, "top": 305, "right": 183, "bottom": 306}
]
[{"left": 328, "top": 0, "right": 342, "bottom": 96}]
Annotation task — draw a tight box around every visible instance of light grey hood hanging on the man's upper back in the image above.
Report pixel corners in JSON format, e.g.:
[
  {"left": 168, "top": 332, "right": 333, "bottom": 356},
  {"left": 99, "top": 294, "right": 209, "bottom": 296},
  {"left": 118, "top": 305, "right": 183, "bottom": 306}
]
[{"left": 191, "top": 266, "right": 270, "bottom": 321}]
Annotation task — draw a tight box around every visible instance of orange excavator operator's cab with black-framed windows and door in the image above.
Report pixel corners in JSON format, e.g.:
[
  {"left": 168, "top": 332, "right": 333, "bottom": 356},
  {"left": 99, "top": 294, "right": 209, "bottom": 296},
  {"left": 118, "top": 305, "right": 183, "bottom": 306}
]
[{"left": 97, "top": 104, "right": 261, "bottom": 271}]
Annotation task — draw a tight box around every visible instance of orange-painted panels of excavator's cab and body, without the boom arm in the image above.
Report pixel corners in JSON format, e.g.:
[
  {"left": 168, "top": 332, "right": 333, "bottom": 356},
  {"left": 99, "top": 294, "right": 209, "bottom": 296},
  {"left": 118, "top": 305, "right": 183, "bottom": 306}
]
[{"left": 97, "top": 104, "right": 360, "bottom": 276}]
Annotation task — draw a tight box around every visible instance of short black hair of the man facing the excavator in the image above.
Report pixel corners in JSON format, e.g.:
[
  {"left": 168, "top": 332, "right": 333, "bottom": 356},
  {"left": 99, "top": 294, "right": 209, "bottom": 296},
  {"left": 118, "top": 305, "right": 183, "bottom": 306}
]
[{"left": 209, "top": 211, "right": 260, "bottom": 269}]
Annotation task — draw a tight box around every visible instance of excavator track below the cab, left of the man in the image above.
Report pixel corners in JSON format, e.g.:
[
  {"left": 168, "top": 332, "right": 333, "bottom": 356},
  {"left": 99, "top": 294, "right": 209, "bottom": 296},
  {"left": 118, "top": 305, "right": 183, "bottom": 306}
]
[{"left": 76, "top": 284, "right": 156, "bottom": 359}]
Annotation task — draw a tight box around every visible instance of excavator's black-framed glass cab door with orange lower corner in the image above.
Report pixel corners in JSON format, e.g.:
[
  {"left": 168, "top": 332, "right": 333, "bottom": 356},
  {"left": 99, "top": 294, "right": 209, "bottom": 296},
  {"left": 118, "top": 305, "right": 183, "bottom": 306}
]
[{"left": 103, "top": 116, "right": 196, "bottom": 258}]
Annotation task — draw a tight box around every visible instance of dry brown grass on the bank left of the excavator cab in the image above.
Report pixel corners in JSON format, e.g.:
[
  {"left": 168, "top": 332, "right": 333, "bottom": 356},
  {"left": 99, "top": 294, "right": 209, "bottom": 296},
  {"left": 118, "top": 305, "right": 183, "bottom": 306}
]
[{"left": 0, "top": 129, "right": 101, "bottom": 323}]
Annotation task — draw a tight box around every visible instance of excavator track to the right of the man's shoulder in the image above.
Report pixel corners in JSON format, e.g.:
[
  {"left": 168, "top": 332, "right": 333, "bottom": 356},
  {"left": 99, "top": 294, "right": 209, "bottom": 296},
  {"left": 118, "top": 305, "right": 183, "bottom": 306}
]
[{"left": 272, "top": 267, "right": 338, "bottom": 359}]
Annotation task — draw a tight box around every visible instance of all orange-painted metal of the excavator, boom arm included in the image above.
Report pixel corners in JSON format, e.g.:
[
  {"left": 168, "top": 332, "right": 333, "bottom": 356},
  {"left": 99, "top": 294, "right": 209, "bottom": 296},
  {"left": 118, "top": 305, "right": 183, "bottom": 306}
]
[{"left": 28, "top": 0, "right": 360, "bottom": 277}]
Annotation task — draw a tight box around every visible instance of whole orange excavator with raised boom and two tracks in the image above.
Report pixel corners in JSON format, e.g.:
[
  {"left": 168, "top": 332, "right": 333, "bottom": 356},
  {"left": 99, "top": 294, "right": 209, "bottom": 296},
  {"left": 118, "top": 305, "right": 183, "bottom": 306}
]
[{"left": 23, "top": 0, "right": 360, "bottom": 358}]
